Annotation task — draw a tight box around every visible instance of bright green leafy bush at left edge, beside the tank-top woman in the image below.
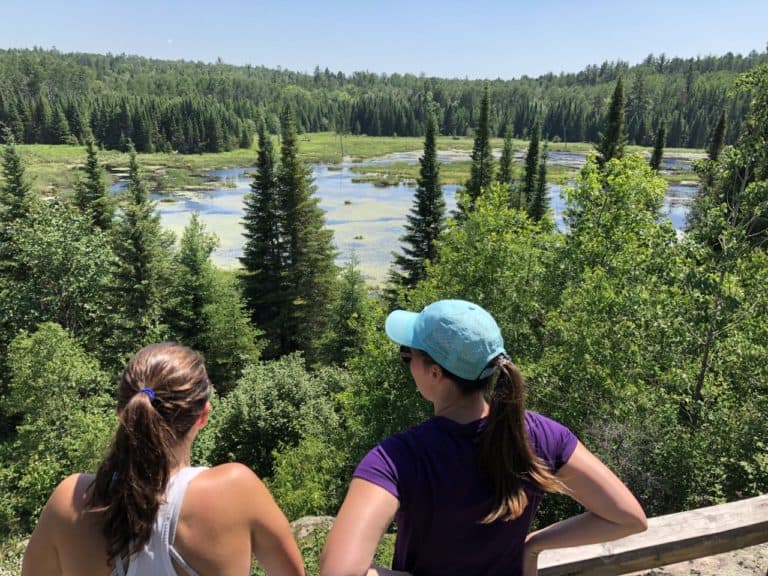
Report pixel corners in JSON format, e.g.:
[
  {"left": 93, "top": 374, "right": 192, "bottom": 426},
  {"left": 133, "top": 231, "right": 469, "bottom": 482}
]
[{"left": 0, "top": 323, "right": 114, "bottom": 529}]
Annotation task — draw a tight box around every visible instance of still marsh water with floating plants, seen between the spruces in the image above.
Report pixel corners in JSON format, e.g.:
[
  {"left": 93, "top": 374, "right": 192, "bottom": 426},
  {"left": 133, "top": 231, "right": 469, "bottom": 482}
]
[{"left": 147, "top": 160, "right": 696, "bottom": 282}]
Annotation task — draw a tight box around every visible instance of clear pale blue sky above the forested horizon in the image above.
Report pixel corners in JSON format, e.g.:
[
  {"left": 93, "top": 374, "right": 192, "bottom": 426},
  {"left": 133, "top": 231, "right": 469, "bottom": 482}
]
[{"left": 0, "top": 0, "right": 768, "bottom": 79}]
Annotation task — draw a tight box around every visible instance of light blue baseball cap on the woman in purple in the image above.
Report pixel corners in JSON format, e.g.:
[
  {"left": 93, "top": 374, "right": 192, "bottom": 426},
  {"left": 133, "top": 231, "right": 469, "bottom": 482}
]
[{"left": 384, "top": 300, "right": 506, "bottom": 380}]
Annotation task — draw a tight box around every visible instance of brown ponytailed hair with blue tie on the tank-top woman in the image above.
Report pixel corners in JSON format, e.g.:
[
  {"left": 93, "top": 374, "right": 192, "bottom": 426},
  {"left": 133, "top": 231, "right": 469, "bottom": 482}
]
[{"left": 87, "top": 342, "right": 211, "bottom": 562}]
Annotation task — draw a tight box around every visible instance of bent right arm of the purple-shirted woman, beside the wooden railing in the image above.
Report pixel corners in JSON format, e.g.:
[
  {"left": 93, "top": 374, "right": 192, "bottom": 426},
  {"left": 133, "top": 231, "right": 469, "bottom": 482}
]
[{"left": 524, "top": 442, "right": 647, "bottom": 576}]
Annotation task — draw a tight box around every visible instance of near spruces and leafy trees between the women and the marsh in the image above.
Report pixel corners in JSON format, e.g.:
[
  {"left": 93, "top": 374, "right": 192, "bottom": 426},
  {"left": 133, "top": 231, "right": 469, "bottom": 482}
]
[{"left": 0, "top": 60, "right": 768, "bottom": 572}]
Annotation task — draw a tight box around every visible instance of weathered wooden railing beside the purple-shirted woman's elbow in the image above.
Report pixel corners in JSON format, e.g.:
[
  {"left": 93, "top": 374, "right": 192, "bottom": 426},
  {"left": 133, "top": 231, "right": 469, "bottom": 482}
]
[{"left": 539, "top": 494, "right": 768, "bottom": 576}]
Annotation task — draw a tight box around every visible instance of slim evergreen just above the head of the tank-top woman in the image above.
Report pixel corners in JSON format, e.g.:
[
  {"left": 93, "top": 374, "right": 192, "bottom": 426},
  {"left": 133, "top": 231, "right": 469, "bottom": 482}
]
[{"left": 115, "top": 146, "right": 169, "bottom": 354}]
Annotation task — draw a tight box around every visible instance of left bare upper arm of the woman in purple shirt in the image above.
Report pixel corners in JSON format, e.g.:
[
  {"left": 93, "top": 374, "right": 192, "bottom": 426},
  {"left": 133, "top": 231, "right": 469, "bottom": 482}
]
[{"left": 320, "top": 478, "right": 406, "bottom": 576}]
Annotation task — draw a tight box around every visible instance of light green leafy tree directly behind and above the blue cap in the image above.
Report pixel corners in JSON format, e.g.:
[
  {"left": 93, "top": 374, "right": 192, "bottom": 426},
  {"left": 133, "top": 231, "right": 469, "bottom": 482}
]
[{"left": 409, "top": 184, "right": 561, "bottom": 359}]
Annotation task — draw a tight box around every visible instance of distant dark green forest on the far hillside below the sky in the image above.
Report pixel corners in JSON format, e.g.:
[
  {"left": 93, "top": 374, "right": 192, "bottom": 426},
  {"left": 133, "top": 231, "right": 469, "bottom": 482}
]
[{"left": 0, "top": 49, "right": 768, "bottom": 152}]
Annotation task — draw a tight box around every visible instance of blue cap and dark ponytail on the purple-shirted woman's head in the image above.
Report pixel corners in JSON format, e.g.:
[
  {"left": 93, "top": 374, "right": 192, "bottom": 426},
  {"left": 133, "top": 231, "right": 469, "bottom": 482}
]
[{"left": 385, "top": 300, "right": 560, "bottom": 523}]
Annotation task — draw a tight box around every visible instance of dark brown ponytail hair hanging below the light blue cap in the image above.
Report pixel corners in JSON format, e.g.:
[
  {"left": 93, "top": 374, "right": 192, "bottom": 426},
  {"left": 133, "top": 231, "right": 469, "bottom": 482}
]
[{"left": 419, "top": 350, "right": 564, "bottom": 524}]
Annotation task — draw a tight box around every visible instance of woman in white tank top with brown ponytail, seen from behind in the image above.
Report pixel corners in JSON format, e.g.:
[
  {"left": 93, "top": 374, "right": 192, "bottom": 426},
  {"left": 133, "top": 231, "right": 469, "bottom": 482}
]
[{"left": 22, "top": 342, "right": 304, "bottom": 576}]
